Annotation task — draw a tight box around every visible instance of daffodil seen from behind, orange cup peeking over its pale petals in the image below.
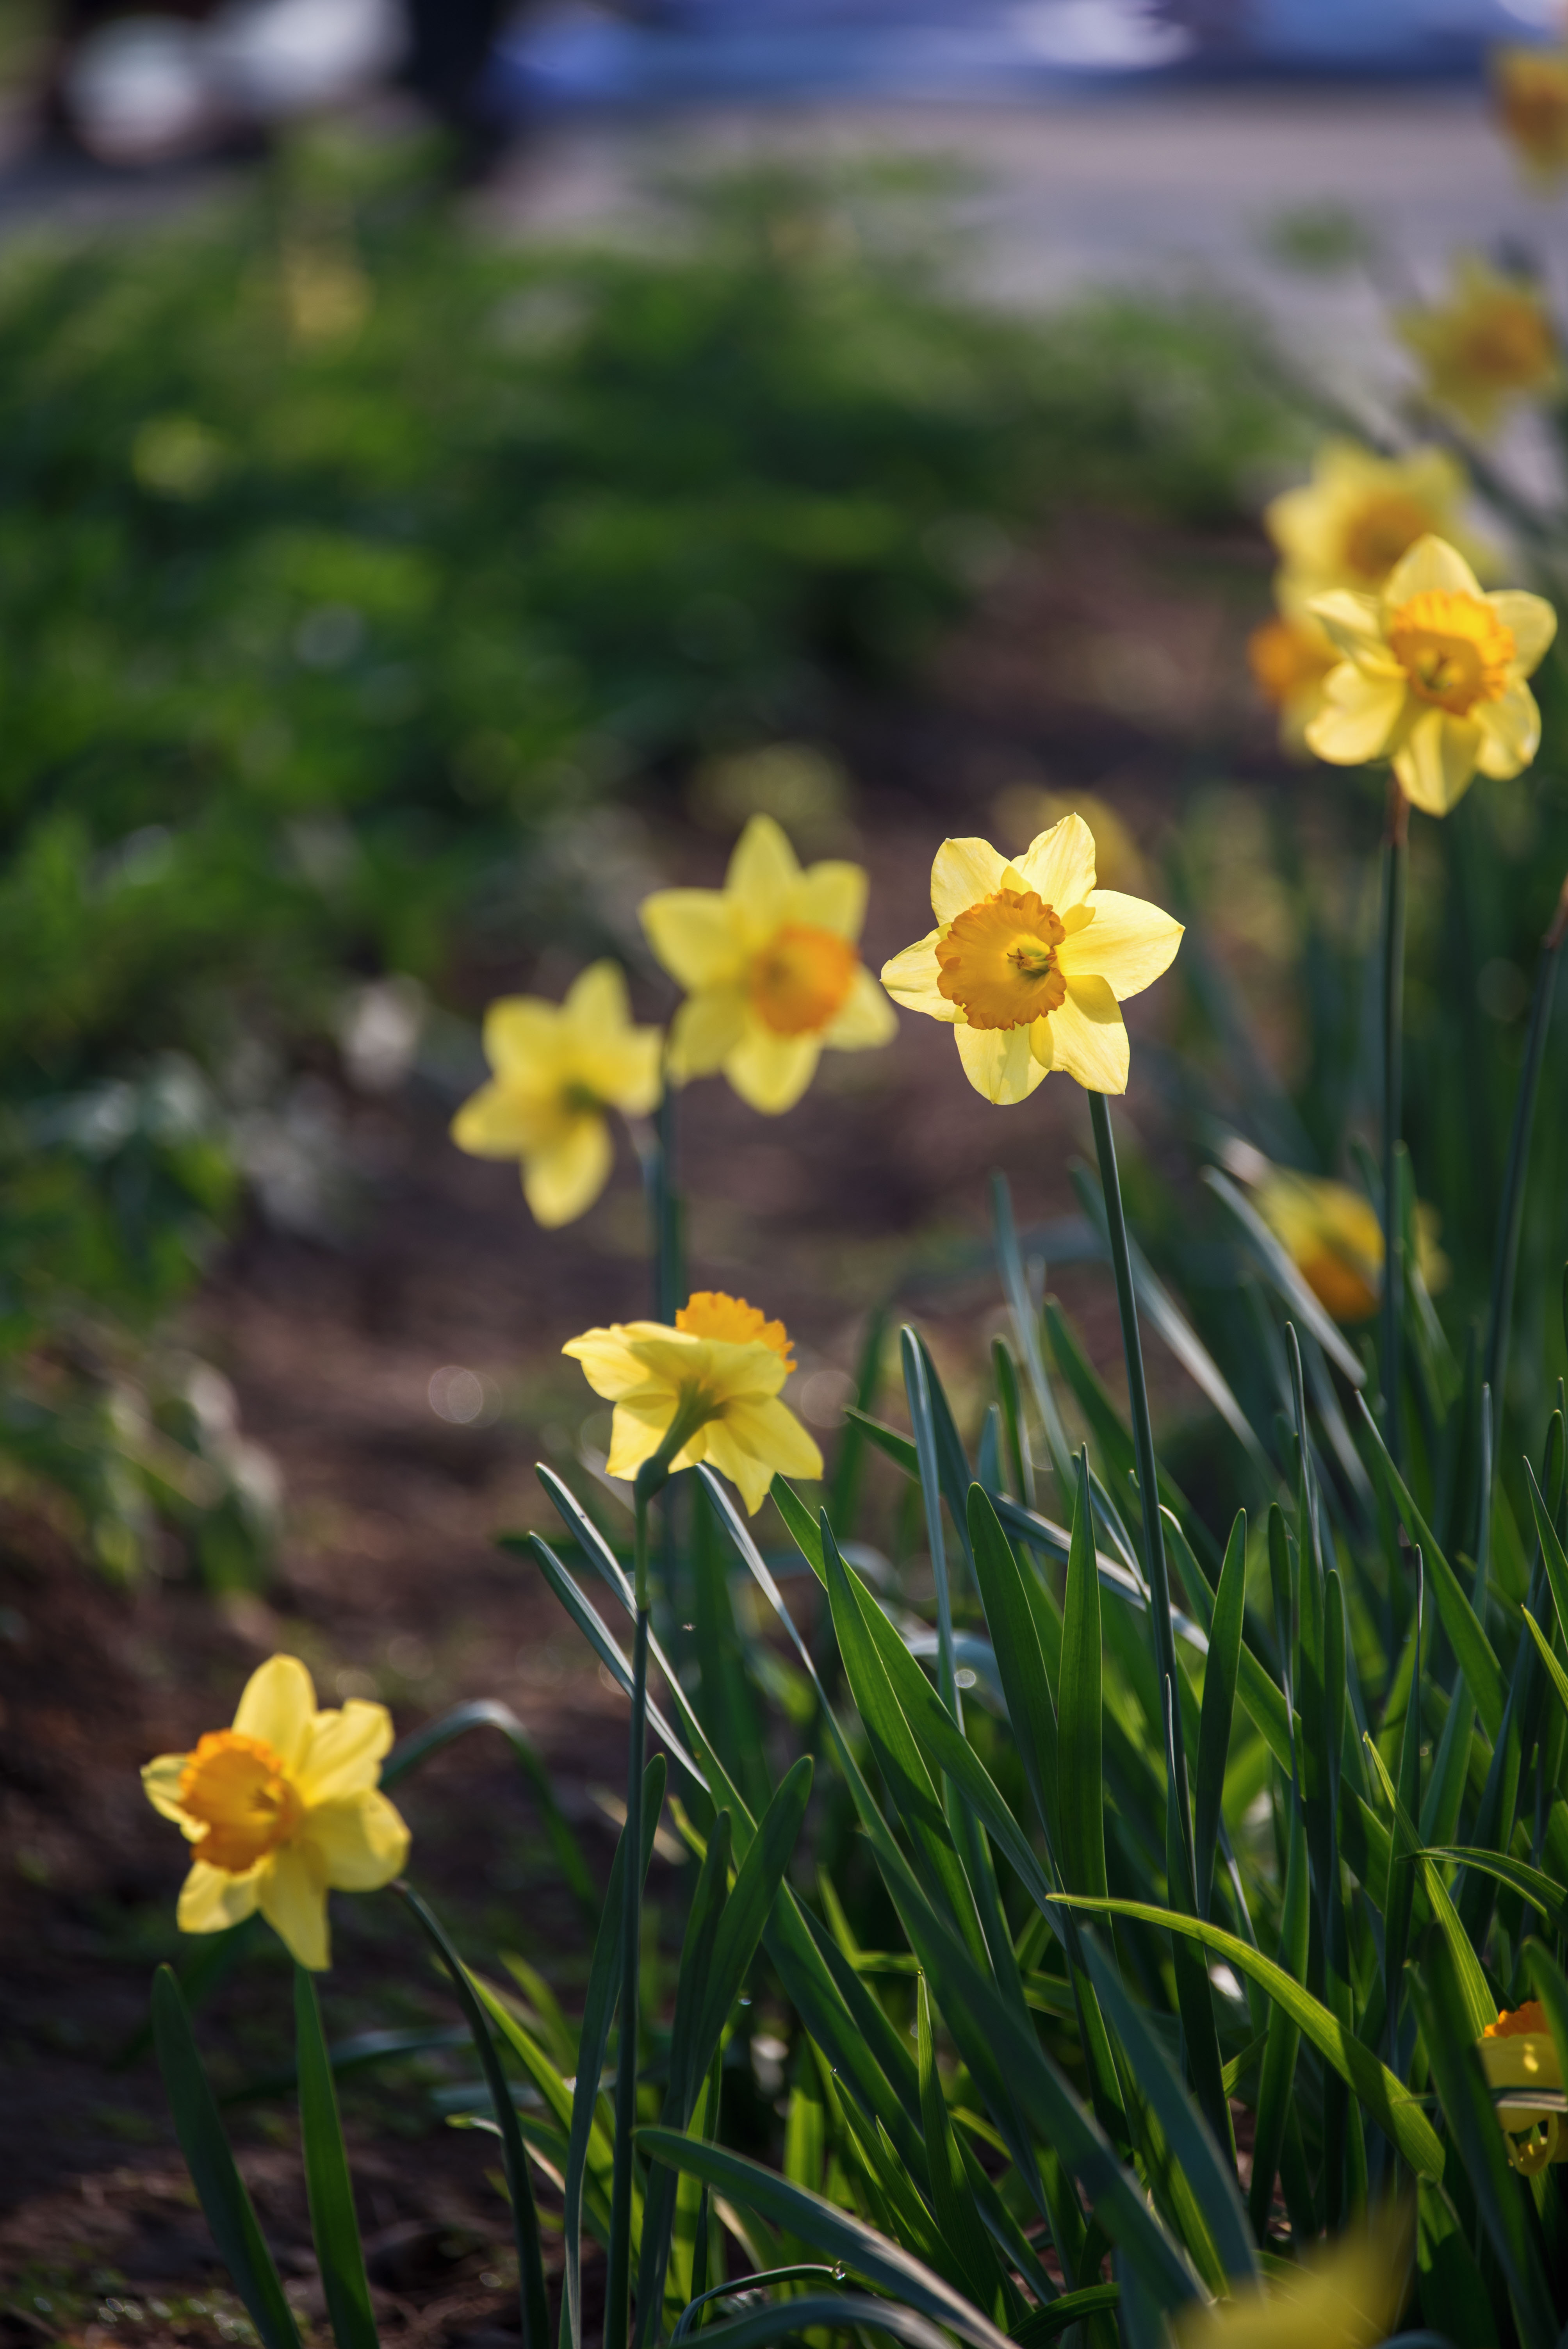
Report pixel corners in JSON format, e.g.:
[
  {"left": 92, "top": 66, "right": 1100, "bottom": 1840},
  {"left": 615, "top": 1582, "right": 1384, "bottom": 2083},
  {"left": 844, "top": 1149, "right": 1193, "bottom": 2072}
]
[{"left": 561, "top": 1290, "right": 821, "bottom": 1517}]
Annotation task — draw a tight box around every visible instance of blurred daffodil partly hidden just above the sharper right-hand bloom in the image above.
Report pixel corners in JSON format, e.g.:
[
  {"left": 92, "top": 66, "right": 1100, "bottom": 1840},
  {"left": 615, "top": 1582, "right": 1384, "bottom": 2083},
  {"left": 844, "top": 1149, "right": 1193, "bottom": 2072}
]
[{"left": 1263, "top": 439, "right": 1479, "bottom": 622}]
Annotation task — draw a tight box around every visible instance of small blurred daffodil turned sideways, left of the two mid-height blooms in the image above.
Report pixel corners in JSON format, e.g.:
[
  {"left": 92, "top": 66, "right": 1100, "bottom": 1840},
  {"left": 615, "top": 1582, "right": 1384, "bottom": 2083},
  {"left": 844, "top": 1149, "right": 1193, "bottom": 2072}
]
[{"left": 453, "top": 963, "right": 659, "bottom": 1228}]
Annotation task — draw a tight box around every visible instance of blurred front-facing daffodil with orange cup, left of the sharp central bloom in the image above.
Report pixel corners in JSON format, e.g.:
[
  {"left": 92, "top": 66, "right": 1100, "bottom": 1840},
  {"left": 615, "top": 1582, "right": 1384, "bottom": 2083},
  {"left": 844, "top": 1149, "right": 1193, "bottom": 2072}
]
[{"left": 643, "top": 815, "right": 897, "bottom": 1116}]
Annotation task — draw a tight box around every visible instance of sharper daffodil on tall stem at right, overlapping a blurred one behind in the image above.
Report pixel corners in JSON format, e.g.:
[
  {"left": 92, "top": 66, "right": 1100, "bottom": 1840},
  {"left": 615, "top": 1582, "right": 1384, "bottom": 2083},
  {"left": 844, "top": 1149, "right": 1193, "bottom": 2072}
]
[{"left": 1308, "top": 538, "right": 1556, "bottom": 815}]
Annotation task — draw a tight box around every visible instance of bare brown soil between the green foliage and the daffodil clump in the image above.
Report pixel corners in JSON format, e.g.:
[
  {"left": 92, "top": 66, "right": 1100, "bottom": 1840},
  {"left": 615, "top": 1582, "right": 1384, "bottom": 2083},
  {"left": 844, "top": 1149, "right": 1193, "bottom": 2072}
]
[{"left": 0, "top": 505, "right": 1270, "bottom": 2349}]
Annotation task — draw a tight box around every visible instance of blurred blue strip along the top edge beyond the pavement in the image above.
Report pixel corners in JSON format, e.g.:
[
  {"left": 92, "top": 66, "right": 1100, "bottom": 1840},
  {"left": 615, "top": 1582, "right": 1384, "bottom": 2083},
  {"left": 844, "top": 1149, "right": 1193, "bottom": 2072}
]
[{"left": 491, "top": 0, "right": 1556, "bottom": 113}]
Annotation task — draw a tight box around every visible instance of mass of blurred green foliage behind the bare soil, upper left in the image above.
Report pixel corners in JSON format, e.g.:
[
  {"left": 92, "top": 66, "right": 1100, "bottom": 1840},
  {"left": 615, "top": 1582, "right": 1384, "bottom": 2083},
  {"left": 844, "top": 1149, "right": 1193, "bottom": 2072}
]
[{"left": 0, "top": 139, "right": 1284, "bottom": 1578}]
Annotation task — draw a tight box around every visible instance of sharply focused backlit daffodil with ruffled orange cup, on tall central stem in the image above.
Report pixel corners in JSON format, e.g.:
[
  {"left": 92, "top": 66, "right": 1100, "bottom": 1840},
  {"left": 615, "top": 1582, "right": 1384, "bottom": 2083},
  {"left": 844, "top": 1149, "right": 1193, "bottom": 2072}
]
[{"left": 883, "top": 815, "right": 1181, "bottom": 1102}]
